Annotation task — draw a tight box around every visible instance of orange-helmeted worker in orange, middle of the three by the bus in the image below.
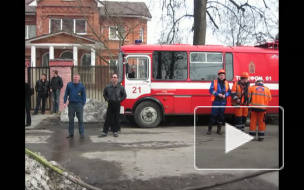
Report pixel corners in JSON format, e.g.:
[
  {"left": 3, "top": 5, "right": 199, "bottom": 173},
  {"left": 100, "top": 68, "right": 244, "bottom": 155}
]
[{"left": 231, "top": 72, "right": 250, "bottom": 131}]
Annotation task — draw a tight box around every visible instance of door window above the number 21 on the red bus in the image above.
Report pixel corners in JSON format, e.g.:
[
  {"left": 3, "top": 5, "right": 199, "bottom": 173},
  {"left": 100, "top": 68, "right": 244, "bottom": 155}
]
[{"left": 127, "top": 58, "right": 148, "bottom": 80}]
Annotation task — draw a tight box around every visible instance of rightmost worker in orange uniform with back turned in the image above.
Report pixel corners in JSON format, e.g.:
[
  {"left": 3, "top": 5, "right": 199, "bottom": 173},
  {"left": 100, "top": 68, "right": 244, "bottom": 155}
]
[{"left": 249, "top": 78, "right": 271, "bottom": 141}]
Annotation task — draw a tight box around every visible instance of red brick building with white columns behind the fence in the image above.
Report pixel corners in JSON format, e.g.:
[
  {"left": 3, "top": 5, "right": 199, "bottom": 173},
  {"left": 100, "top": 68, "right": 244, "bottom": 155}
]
[{"left": 25, "top": 0, "right": 152, "bottom": 67}]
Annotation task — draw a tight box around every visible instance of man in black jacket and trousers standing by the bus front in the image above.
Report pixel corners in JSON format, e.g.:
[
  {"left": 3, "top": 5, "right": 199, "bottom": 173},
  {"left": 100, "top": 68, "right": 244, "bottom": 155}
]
[{"left": 99, "top": 74, "right": 127, "bottom": 137}]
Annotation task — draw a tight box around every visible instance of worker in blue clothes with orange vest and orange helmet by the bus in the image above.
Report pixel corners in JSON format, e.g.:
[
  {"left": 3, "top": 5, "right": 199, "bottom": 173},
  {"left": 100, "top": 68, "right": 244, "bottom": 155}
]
[{"left": 207, "top": 69, "right": 231, "bottom": 135}]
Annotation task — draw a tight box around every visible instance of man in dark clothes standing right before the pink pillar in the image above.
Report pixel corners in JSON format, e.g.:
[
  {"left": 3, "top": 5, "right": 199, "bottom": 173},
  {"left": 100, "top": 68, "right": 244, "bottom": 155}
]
[{"left": 50, "top": 70, "right": 63, "bottom": 113}]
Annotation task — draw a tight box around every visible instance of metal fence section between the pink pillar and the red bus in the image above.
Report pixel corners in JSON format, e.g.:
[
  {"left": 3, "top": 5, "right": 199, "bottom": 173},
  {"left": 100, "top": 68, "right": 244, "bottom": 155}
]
[{"left": 71, "top": 65, "right": 117, "bottom": 102}]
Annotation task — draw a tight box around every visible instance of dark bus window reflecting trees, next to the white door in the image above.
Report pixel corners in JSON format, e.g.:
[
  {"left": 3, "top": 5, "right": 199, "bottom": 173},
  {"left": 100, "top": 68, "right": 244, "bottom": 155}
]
[{"left": 153, "top": 51, "right": 188, "bottom": 80}]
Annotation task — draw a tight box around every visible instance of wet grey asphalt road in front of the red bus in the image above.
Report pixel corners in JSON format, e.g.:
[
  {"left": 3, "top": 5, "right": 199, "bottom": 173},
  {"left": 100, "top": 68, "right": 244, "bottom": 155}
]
[{"left": 25, "top": 115, "right": 280, "bottom": 189}]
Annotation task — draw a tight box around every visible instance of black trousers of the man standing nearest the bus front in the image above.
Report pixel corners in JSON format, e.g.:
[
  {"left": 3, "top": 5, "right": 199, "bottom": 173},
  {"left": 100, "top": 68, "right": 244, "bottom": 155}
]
[{"left": 102, "top": 102, "right": 120, "bottom": 133}]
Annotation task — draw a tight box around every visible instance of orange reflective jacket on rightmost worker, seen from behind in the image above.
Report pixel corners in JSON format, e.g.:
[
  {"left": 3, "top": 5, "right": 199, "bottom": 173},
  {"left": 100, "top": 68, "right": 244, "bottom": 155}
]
[{"left": 249, "top": 85, "right": 272, "bottom": 110}]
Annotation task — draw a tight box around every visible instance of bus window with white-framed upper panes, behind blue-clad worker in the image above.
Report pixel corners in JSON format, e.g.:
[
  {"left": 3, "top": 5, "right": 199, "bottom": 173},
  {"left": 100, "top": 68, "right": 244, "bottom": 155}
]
[{"left": 190, "top": 52, "right": 223, "bottom": 81}]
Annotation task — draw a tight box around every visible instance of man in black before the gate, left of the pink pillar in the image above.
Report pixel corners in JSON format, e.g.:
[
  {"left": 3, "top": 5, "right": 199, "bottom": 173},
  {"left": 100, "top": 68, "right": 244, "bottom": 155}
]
[{"left": 33, "top": 73, "right": 50, "bottom": 115}]
